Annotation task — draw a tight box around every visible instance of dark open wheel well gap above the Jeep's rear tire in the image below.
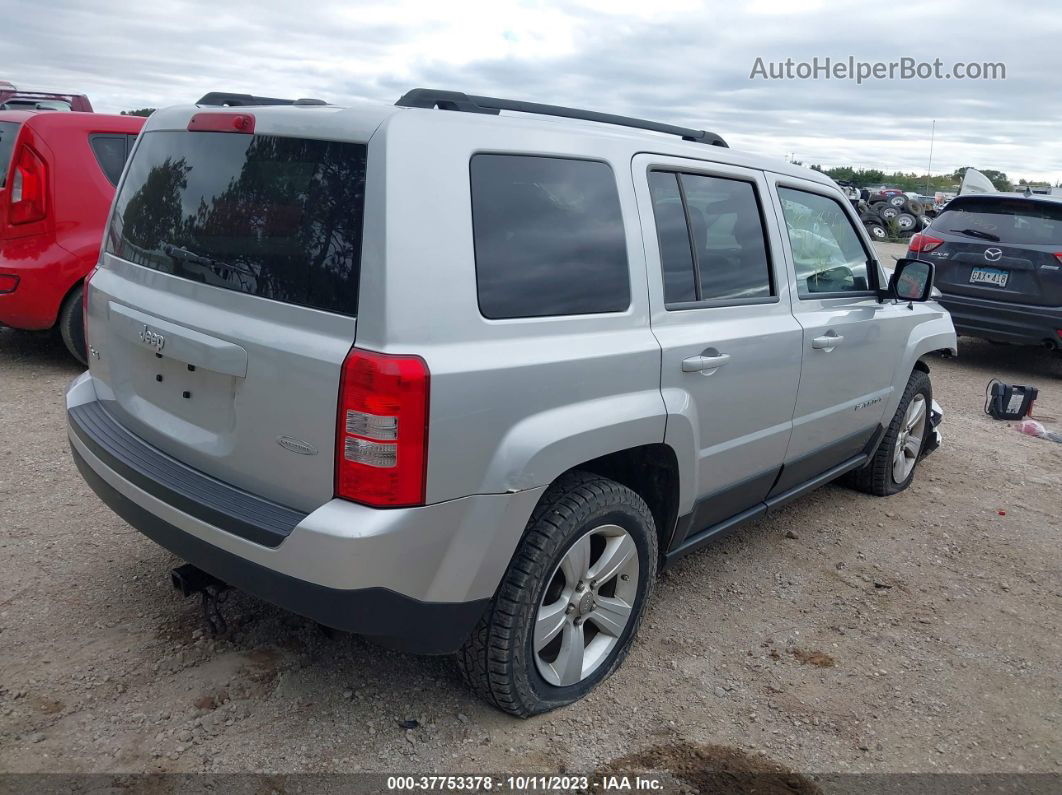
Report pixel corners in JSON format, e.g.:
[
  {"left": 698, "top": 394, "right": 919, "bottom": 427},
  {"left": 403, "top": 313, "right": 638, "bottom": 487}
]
[{"left": 569, "top": 445, "right": 679, "bottom": 554}]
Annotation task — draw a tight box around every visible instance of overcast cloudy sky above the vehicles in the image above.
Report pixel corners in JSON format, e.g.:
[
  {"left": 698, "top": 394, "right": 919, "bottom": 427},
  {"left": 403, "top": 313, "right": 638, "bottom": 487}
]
[{"left": 8, "top": 0, "right": 1062, "bottom": 183}]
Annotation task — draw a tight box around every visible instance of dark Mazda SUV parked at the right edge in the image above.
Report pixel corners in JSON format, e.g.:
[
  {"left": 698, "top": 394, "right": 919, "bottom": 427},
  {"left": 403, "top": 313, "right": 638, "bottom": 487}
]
[{"left": 908, "top": 193, "right": 1062, "bottom": 350}]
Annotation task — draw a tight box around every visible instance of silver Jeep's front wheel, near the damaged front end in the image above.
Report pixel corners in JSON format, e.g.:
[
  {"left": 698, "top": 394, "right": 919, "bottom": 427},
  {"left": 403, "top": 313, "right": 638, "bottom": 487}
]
[{"left": 845, "top": 369, "right": 932, "bottom": 497}]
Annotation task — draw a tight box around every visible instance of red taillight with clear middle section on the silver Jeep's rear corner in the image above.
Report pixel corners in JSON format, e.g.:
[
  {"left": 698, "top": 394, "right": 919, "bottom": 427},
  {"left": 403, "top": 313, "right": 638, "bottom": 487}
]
[{"left": 336, "top": 348, "right": 429, "bottom": 507}]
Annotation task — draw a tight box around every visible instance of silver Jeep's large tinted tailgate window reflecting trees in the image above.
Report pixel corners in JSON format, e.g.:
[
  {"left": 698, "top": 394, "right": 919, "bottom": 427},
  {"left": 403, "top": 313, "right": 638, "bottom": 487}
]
[{"left": 107, "top": 132, "right": 366, "bottom": 315}]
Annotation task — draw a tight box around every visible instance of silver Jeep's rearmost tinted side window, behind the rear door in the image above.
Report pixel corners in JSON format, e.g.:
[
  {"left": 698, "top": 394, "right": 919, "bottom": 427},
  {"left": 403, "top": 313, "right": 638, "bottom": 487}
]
[{"left": 469, "top": 155, "right": 631, "bottom": 318}]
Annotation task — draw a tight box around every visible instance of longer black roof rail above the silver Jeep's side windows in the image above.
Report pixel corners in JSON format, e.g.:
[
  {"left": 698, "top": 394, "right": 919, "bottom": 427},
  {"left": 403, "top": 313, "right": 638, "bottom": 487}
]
[{"left": 395, "top": 88, "right": 727, "bottom": 146}]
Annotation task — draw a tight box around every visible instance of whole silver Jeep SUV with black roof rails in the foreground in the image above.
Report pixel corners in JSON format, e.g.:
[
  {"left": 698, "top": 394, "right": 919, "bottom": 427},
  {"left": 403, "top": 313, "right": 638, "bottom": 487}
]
[{"left": 67, "top": 89, "right": 956, "bottom": 715}]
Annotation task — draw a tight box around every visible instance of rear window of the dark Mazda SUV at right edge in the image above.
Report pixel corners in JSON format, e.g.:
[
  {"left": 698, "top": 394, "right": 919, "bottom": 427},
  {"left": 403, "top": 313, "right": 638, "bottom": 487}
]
[{"left": 931, "top": 197, "right": 1062, "bottom": 245}]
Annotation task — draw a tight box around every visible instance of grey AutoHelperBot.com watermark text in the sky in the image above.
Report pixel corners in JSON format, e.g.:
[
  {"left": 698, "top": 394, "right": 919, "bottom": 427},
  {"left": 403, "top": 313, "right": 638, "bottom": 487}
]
[{"left": 749, "top": 55, "right": 1007, "bottom": 84}]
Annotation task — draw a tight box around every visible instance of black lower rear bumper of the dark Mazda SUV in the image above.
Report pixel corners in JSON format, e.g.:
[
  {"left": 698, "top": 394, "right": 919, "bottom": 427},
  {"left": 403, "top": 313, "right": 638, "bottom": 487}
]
[{"left": 939, "top": 294, "right": 1062, "bottom": 346}]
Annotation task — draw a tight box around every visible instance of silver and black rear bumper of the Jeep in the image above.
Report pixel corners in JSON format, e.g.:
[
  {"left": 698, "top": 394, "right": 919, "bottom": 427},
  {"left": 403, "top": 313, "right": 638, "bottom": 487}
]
[{"left": 67, "top": 374, "right": 542, "bottom": 654}]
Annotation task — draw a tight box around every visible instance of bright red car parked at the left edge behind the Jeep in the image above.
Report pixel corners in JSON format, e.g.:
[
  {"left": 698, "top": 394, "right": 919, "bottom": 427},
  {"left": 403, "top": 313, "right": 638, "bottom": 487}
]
[{"left": 0, "top": 110, "right": 144, "bottom": 363}]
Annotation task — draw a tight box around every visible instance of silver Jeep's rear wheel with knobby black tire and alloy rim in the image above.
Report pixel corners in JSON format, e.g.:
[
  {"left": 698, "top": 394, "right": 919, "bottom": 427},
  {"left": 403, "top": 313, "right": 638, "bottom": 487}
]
[{"left": 458, "top": 471, "right": 657, "bottom": 718}]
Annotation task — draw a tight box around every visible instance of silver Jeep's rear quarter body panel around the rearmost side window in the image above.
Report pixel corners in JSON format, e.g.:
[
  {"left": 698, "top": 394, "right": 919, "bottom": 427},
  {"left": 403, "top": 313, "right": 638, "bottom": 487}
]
[{"left": 357, "top": 110, "right": 666, "bottom": 502}]
